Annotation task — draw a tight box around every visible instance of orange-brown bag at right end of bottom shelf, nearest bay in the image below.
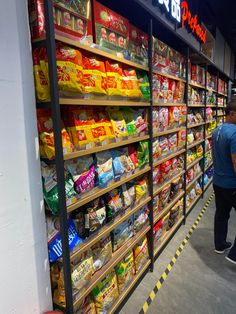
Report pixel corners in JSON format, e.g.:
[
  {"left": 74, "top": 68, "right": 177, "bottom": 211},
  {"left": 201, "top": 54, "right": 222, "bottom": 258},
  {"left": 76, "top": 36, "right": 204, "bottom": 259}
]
[{"left": 134, "top": 236, "right": 149, "bottom": 273}]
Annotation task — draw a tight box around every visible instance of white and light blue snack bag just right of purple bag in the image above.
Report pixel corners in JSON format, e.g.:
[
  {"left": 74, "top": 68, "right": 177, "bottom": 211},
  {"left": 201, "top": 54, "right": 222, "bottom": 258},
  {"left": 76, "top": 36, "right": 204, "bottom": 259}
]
[{"left": 96, "top": 151, "right": 114, "bottom": 188}]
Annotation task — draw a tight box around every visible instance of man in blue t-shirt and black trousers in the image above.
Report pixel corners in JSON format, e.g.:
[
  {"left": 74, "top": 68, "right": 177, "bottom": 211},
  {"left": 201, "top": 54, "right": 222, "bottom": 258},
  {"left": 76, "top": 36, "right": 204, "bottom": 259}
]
[{"left": 212, "top": 100, "right": 236, "bottom": 264}]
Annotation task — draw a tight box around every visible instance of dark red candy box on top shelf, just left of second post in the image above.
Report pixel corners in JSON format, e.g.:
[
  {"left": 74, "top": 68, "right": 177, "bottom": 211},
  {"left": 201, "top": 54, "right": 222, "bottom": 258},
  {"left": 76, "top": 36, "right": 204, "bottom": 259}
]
[{"left": 129, "top": 24, "right": 148, "bottom": 64}]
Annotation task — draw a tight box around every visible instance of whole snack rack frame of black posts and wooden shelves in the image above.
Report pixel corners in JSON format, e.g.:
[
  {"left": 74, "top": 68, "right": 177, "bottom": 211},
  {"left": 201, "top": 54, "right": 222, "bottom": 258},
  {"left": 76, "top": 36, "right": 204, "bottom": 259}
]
[{"left": 32, "top": 0, "right": 227, "bottom": 314}]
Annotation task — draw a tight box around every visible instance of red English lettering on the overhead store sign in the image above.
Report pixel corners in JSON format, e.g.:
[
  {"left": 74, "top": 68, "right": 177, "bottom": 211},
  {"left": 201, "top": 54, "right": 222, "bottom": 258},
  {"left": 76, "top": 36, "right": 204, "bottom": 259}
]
[{"left": 181, "top": 1, "right": 207, "bottom": 44}]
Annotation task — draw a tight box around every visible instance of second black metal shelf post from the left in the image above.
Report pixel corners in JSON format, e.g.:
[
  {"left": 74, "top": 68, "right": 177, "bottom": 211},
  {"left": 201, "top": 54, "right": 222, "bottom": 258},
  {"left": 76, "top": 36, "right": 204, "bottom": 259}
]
[{"left": 148, "top": 19, "right": 154, "bottom": 271}]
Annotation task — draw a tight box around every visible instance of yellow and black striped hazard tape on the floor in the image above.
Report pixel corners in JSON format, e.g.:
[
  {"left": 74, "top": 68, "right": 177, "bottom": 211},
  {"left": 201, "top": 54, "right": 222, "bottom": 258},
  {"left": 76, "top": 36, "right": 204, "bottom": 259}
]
[{"left": 139, "top": 193, "right": 214, "bottom": 314}]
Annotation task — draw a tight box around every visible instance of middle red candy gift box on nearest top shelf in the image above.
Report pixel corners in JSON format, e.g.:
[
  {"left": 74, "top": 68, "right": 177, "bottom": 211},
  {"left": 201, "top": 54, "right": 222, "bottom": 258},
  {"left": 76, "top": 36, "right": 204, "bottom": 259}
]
[{"left": 93, "top": 1, "right": 129, "bottom": 52}]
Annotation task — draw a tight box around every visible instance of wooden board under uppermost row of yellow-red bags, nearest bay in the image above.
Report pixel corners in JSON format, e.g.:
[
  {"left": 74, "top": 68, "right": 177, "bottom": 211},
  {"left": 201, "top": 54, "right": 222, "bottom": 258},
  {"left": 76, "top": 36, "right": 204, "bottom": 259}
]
[{"left": 59, "top": 97, "right": 150, "bottom": 107}]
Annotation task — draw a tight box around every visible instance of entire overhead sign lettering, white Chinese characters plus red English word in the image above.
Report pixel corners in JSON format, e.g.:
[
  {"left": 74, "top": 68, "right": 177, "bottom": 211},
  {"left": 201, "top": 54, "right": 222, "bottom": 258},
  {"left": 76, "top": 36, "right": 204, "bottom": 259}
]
[{"left": 152, "top": 0, "right": 207, "bottom": 44}]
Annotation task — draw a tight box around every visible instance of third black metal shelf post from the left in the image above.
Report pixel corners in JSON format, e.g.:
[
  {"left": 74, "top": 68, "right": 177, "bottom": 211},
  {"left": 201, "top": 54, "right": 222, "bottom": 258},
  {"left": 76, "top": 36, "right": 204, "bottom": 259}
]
[{"left": 183, "top": 47, "right": 189, "bottom": 225}]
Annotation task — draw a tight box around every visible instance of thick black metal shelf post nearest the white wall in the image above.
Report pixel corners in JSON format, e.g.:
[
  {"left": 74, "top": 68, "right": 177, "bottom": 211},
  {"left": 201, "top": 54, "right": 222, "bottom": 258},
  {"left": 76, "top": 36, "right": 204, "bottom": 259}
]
[{"left": 44, "top": 0, "right": 73, "bottom": 314}]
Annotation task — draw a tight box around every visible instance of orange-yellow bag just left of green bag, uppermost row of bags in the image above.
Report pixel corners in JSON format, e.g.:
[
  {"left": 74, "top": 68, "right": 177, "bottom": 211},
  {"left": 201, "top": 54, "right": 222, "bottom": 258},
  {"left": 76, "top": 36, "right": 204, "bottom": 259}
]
[{"left": 122, "top": 69, "right": 142, "bottom": 98}]
